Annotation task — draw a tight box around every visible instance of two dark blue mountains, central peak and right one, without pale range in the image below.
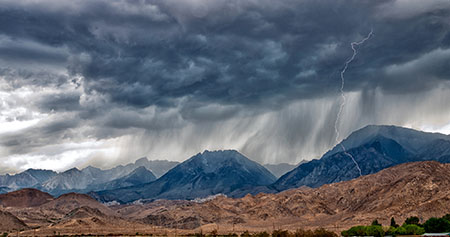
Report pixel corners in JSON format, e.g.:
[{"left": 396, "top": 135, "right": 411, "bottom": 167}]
[{"left": 91, "top": 125, "right": 450, "bottom": 203}]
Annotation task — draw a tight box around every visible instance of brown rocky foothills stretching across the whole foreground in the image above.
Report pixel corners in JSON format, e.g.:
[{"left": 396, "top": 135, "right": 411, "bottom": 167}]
[{"left": 0, "top": 161, "right": 450, "bottom": 235}]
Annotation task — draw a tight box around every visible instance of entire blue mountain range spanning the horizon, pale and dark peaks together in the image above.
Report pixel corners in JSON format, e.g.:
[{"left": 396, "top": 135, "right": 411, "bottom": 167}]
[{"left": 0, "top": 125, "right": 450, "bottom": 203}]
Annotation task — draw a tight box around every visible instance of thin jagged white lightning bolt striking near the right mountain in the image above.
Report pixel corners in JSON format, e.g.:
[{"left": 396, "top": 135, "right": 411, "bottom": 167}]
[{"left": 334, "top": 29, "right": 373, "bottom": 176}]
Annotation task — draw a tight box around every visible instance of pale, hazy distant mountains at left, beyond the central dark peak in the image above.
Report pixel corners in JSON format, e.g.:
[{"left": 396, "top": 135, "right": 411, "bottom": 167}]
[{"left": 0, "top": 158, "right": 178, "bottom": 195}]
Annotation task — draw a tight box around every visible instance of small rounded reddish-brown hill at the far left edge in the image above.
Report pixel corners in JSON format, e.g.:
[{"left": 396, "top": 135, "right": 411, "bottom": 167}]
[{"left": 0, "top": 188, "right": 53, "bottom": 207}]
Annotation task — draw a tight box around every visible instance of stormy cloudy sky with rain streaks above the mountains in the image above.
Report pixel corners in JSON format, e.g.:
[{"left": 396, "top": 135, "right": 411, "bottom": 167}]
[{"left": 0, "top": 0, "right": 450, "bottom": 173}]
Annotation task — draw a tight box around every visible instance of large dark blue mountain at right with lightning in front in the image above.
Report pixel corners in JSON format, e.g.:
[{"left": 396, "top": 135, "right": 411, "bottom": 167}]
[{"left": 270, "top": 125, "right": 450, "bottom": 191}]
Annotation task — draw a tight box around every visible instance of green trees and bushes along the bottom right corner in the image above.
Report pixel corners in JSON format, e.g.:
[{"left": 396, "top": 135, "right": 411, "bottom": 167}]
[{"left": 341, "top": 214, "right": 450, "bottom": 237}]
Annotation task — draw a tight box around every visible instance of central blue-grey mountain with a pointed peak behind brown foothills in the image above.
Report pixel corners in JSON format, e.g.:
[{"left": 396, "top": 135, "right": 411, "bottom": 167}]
[{"left": 92, "top": 150, "right": 276, "bottom": 203}]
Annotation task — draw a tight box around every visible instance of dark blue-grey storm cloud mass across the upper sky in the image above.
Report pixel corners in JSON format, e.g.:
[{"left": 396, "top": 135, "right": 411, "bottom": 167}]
[{"left": 0, "top": 1, "right": 449, "bottom": 107}]
